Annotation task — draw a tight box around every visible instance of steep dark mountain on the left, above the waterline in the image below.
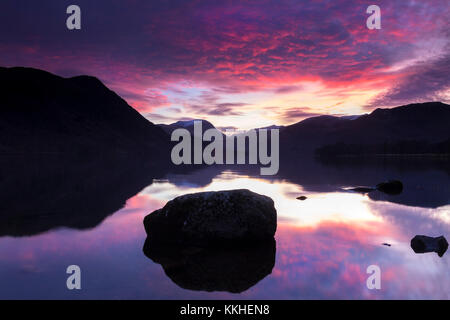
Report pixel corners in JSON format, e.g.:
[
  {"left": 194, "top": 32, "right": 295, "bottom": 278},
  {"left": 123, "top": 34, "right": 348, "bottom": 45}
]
[{"left": 0, "top": 68, "right": 169, "bottom": 161}]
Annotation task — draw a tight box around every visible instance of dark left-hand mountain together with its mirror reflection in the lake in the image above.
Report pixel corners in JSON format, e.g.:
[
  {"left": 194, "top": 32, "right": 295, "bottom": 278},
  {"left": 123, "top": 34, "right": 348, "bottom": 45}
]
[{"left": 0, "top": 68, "right": 174, "bottom": 237}]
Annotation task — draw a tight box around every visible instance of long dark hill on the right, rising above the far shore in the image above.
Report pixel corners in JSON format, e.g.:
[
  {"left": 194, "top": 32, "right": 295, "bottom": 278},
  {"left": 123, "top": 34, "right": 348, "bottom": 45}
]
[{"left": 280, "top": 102, "right": 450, "bottom": 159}]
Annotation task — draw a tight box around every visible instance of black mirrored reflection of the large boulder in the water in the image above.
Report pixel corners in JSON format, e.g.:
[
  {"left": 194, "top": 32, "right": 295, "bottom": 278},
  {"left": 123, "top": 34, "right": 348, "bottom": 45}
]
[{"left": 143, "top": 238, "right": 276, "bottom": 293}]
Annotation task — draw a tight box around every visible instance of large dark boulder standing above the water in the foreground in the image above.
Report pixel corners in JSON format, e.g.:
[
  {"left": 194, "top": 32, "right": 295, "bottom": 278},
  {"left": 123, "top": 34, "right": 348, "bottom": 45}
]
[{"left": 144, "top": 190, "right": 277, "bottom": 247}]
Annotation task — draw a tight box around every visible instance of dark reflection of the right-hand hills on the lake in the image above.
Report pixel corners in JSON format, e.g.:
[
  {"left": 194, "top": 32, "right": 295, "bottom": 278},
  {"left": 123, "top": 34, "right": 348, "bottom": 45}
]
[{"left": 279, "top": 157, "right": 450, "bottom": 208}]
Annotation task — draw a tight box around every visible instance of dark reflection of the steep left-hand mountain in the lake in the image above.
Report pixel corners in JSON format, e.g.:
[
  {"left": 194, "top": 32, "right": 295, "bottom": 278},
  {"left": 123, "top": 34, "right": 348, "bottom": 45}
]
[{"left": 0, "top": 156, "right": 165, "bottom": 237}]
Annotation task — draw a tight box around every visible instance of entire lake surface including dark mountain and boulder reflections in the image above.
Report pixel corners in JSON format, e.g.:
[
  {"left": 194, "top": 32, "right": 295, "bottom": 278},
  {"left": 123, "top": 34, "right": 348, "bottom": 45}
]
[{"left": 0, "top": 158, "right": 450, "bottom": 299}]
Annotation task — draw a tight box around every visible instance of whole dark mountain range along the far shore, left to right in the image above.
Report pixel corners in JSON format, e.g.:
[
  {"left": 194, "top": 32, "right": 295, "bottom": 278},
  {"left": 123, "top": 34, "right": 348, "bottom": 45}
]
[{"left": 0, "top": 68, "right": 450, "bottom": 162}]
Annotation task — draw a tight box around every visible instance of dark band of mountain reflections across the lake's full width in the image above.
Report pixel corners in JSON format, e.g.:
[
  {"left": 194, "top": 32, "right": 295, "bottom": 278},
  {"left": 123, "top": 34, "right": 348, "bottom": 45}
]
[{"left": 0, "top": 152, "right": 450, "bottom": 236}]
